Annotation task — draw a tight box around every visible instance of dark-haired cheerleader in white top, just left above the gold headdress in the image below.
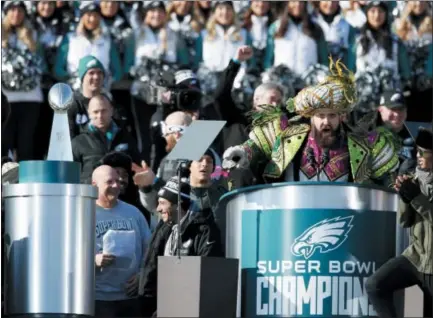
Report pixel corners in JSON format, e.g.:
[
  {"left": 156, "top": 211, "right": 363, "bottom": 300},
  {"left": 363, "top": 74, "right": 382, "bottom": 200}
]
[{"left": 265, "top": 1, "right": 328, "bottom": 75}]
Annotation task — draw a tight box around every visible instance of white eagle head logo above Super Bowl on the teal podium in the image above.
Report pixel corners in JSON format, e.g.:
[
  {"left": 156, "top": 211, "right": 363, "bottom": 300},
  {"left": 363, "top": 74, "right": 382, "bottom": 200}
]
[{"left": 292, "top": 216, "right": 353, "bottom": 259}]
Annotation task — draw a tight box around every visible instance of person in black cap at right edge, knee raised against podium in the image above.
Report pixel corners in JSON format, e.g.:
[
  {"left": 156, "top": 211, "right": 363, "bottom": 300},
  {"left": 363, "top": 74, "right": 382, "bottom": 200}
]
[{"left": 366, "top": 128, "right": 433, "bottom": 317}]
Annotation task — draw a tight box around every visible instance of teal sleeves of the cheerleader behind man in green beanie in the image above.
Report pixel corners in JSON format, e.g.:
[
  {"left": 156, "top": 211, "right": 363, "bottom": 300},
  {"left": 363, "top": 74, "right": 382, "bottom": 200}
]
[{"left": 54, "top": 34, "right": 123, "bottom": 82}]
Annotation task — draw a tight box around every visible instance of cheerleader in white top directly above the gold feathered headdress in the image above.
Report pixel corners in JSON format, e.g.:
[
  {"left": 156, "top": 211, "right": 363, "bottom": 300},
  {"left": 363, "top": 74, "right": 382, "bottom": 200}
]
[{"left": 313, "top": 1, "right": 356, "bottom": 70}]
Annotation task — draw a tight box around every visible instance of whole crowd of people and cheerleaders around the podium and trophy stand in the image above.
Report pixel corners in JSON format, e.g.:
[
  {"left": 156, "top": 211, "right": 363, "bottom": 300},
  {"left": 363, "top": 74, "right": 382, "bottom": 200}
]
[{"left": 1, "top": 1, "right": 433, "bottom": 317}]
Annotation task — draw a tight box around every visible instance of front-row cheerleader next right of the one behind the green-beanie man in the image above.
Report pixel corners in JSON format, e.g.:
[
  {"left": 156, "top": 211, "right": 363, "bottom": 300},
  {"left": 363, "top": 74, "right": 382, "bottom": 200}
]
[{"left": 125, "top": 1, "right": 188, "bottom": 163}]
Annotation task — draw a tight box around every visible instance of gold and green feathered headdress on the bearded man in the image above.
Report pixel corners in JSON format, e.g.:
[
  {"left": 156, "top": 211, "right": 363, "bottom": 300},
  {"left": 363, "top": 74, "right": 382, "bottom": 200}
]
[{"left": 287, "top": 58, "right": 357, "bottom": 117}]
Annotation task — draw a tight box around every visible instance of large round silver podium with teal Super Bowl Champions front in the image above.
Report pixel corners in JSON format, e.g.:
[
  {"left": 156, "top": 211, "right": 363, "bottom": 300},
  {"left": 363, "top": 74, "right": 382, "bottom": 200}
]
[{"left": 217, "top": 182, "right": 404, "bottom": 317}]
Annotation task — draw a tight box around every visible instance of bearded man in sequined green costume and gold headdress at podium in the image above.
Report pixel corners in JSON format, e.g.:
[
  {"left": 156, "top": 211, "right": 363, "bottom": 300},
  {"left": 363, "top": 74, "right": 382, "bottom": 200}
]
[{"left": 223, "top": 61, "right": 399, "bottom": 186}]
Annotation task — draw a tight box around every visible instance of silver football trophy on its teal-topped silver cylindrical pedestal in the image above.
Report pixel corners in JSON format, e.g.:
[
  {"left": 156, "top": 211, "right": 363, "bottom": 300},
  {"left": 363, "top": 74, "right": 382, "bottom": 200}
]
[{"left": 3, "top": 83, "right": 97, "bottom": 317}]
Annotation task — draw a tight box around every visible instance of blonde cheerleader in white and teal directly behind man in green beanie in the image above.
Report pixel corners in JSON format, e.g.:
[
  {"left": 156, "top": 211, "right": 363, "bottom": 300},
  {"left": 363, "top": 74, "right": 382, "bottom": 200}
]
[{"left": 54, "top": 1, "right": 122, "bottom": 89}]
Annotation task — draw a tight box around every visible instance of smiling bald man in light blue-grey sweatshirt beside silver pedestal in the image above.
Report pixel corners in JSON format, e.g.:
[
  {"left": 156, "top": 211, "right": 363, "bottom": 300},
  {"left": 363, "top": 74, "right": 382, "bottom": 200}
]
[{"left": 92, "top": 166, "right": 151, "bottom": 318}]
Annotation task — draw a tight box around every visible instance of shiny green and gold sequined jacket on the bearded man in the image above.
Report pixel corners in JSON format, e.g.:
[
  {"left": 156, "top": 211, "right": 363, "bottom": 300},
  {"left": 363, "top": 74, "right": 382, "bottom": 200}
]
[{"left": 242, "top": 111, "right": 399, "bottom": 186}]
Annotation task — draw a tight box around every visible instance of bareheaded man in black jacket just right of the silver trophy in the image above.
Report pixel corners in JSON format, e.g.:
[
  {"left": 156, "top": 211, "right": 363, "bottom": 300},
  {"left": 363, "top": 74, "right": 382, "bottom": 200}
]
[{"left": 72, "top": 95, "right": 141, "bottom": 183}]
